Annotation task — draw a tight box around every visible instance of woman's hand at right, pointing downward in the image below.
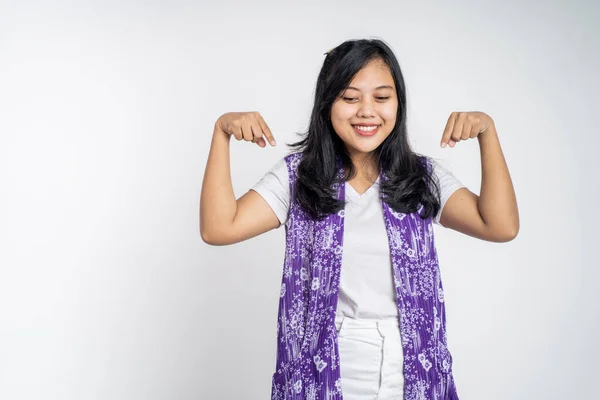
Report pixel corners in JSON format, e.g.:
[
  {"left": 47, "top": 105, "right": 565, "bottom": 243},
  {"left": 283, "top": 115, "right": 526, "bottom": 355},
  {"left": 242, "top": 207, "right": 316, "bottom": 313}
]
[{"left": 440, "top": 111, "right": 494, "bottom": 147}]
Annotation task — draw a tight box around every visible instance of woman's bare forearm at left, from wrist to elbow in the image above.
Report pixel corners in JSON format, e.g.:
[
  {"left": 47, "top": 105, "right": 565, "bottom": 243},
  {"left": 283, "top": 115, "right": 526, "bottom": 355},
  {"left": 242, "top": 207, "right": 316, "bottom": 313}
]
[{"left": 200, "top": 123, "right": 237, "bottom": 240}]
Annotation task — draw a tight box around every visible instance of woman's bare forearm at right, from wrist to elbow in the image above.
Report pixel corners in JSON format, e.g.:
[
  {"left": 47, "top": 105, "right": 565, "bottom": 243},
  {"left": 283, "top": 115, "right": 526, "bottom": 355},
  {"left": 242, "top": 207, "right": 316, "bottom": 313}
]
[{"left": 477, "top": 122, "right": 519, "bottom": 237}]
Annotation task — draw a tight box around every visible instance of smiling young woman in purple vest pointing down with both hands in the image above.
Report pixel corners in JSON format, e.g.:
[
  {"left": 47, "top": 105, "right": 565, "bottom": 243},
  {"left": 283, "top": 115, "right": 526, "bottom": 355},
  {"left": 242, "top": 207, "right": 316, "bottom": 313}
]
[{"left": 200, "top": 39, "right": 519, "bottom": 400}]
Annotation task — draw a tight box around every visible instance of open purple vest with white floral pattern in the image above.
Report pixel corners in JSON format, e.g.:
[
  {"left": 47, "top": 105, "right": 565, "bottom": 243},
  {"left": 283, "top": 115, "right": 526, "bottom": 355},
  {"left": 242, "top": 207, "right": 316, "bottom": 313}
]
[{"left": 271, "top": 153, "right": 458, "bottom": 400}]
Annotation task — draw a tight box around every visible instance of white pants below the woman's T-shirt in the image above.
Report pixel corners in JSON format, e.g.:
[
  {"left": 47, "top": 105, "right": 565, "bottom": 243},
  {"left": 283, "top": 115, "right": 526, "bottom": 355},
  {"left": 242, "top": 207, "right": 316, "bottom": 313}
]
[{"left": 335, "top": 316, "right": 404, "bottom": 400}]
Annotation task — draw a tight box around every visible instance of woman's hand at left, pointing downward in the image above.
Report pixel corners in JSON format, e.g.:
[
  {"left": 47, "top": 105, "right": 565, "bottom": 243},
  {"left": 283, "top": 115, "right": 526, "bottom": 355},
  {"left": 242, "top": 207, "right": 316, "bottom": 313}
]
[{"left": 217, "top": 111, "right": 276, "bottom": 147}]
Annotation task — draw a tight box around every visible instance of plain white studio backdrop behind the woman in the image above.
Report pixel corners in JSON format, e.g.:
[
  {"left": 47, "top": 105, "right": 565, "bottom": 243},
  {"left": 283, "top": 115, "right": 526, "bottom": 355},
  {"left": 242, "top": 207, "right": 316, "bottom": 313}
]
[{"left": 0, "top": 0, "right": 600, "bottom": 400}]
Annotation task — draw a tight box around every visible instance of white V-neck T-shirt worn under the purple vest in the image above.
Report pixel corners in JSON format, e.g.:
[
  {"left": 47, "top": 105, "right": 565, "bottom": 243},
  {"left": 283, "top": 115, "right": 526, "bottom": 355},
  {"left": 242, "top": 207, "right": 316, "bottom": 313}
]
[{"left": 252, "top": 158, "right": 464, "bottom": 319}]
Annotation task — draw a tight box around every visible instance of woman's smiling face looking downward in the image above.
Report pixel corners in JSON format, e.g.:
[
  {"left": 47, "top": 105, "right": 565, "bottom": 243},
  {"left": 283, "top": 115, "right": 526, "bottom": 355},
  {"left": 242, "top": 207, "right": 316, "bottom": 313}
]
[{"left": 331, "top": 59, "right": 398, "bottom": 166}]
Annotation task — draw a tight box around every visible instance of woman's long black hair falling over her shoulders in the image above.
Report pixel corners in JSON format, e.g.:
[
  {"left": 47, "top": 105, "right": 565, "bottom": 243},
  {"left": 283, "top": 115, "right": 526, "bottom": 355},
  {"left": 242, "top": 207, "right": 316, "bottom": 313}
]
[{"left": 288, "top": 39, "right": 440, "bottom": 219}]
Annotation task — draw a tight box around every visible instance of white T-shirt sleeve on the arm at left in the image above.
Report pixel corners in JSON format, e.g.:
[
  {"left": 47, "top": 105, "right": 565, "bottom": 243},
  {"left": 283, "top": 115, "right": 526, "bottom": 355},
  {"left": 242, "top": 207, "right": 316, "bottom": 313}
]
[{"left": 251, "top": 158, "right": 290, "bottom": 230}]
